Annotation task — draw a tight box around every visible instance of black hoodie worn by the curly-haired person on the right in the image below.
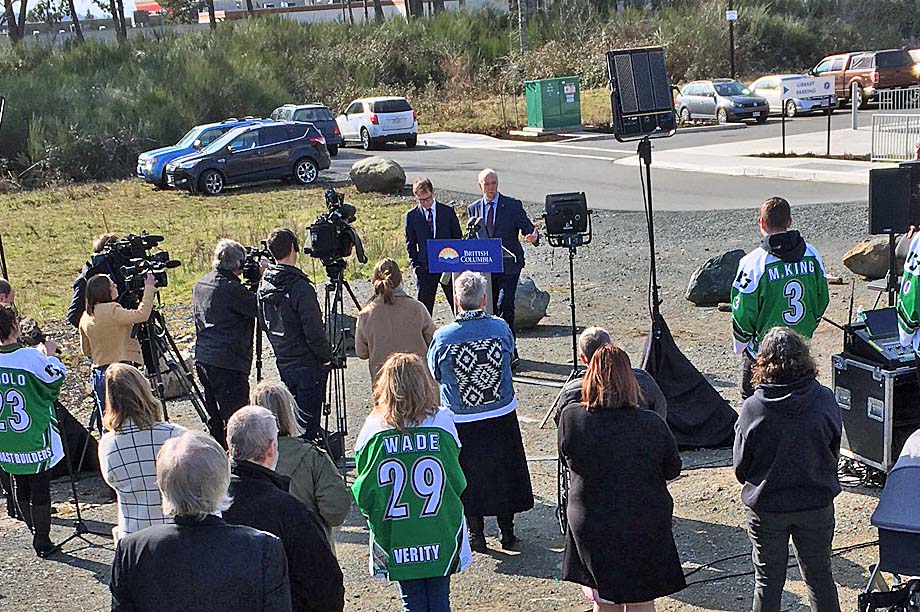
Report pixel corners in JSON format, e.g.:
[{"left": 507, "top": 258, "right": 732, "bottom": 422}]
[{"left": 734, "top": 378, "right": 841, "bottom": 512}]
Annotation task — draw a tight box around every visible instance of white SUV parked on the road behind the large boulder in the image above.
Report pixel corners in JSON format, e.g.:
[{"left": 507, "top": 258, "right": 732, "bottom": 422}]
[{"left": 336, "top": 98, "right": 418, "bottom": 151}]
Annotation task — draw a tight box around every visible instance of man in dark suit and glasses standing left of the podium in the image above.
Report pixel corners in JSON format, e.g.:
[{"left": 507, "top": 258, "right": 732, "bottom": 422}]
[{"left": 405, "top": 177, "right": 463, "bottom": 313}]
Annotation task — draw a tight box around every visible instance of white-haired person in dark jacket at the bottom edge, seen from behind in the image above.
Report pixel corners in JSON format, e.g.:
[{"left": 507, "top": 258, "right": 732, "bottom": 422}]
[{"left": 109, "top": 431, "right": 291, "bottom": 612}]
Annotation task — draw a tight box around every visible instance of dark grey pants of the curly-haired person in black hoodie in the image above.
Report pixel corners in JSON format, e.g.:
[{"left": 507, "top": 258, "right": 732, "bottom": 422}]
[{"left": 747, "top": 504, "right": 840, "bottom": 612}]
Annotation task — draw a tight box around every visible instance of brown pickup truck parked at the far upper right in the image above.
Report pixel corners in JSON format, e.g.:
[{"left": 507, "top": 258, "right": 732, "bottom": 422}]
[{"left": 809, "top": 49, "right": 917, "bottom": 108}]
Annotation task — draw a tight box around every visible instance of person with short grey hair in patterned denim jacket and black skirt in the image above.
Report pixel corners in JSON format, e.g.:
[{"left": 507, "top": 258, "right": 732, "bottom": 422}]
[{"left": 428, "top": 272, "right": 533, "bottom": 552}]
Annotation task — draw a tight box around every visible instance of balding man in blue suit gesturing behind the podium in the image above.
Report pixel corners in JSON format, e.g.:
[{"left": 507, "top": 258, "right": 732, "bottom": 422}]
[{"left": 467, "top": 168, "right": 540, "bottom": 366}]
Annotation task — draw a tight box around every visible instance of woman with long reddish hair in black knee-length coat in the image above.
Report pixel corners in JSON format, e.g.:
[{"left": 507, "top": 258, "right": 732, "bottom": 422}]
[{"left": 559, "top": 345, "right": 686, "bottom": 612}]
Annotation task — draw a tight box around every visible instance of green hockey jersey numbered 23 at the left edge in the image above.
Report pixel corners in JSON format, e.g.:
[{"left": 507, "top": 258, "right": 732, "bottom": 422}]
[{"left": 0, "top": 345, "right": 67, "bottom": 474}]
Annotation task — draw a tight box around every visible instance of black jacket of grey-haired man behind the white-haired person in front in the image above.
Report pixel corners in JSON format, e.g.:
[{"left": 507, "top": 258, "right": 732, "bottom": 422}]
[{"left": 224, "top": 461, "right": 345, "bottom": 612}]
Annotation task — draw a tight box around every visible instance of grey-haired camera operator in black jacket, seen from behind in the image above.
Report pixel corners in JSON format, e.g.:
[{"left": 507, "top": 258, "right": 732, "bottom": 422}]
[{"left": 192, "top": 239, "right": 259, "bottom": 446}]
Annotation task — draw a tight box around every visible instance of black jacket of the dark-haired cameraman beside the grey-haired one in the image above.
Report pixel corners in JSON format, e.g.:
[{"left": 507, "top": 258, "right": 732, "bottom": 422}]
[{"left": 259, "top": 264, "right": 332, "bottom": 368}]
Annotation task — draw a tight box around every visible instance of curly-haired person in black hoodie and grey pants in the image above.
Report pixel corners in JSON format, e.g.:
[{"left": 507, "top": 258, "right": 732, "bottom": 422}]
[{"left": 733, "top": 327, "right": 841, "bottom": 612}]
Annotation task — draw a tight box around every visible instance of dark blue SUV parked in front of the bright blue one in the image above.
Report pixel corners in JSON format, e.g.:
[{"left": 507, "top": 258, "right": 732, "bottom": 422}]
[{"left": 166, "top": 121, "right": 330, "bottom": 195}]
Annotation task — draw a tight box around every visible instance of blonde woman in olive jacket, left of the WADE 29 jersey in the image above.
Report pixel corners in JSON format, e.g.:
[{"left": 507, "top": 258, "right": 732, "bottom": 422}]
[{"left": 249, "top": 380, "right": 351, "bottom": 552}]
